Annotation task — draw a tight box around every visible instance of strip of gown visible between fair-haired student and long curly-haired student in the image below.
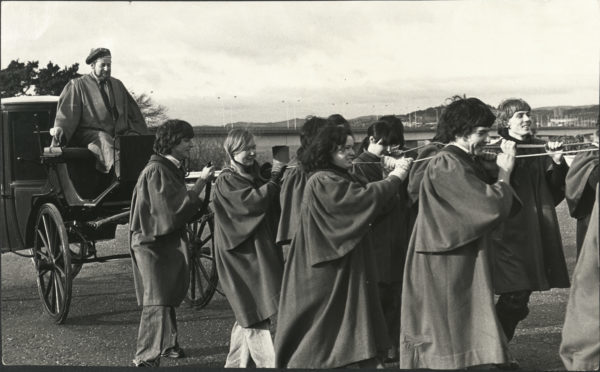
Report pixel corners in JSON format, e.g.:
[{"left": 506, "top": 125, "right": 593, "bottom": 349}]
[{"left": 277, "top": 161, "right": 308, "bottom": 250}]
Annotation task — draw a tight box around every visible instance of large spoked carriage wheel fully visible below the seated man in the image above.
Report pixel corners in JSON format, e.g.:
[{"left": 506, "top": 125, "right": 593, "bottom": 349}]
[{"left": 32, "top": 203, "right": 72, "bottom": 324}]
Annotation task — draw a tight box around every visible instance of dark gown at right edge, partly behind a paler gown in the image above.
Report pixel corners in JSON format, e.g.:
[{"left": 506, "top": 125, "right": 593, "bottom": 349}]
[{"left": 565, "top": 147, "right": 598, "bottom": 256}]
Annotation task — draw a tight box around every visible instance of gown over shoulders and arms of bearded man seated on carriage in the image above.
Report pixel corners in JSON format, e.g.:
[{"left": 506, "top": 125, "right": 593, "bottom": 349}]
[{"left": 54, "top": 74, "right": 148, "bottom": 146}]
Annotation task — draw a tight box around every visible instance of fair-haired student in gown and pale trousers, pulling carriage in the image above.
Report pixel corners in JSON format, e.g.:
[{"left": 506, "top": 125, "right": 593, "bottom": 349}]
[{"left": 213, "top": 129, "right": 283, "bottom": 368}]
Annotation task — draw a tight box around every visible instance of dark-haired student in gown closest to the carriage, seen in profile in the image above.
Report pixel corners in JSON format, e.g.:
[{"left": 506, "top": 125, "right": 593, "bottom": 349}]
[{"left": 129, "top": 120, "right": 213, "bottom": 367}]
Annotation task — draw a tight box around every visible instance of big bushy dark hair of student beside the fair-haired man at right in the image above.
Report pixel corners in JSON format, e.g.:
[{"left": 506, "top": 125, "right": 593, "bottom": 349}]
[{"left": 436, "top": 96, "right": 496, "bottom": 143}]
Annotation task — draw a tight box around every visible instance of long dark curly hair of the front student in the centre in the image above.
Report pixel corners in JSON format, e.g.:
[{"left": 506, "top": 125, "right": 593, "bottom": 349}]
[{"left": 298, "top": 125, "right": 352, "bottom": 172}]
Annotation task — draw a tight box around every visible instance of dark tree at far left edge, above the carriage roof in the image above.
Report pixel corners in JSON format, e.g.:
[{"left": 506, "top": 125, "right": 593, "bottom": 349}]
[{"left": 0, "top": 59, "right": 38, "bottom": 98}]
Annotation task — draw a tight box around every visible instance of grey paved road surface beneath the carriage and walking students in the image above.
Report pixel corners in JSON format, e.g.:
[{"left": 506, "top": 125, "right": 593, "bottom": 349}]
[{"left": 1, "top": 202, "right": 575, "bottom": 370}]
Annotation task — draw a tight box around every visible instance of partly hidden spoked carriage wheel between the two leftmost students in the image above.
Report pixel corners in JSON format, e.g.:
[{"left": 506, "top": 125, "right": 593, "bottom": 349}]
[{"left": 186, "top": 212, "right": 219, "bottom": 309}]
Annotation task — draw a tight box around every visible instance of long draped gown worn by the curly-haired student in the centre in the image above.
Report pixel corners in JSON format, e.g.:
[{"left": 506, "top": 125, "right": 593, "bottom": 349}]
[{"left": 275, "top": 169, "right": 401, "bottom": 368}]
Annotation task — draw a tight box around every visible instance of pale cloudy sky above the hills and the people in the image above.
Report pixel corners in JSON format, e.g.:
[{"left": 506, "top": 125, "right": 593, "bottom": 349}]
[{"left": 0, "top": 0, "right": 600, "bottom": 125}]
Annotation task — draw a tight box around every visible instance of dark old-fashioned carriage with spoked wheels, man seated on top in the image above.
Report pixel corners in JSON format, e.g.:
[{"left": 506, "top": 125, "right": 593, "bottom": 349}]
[{"left": 0, "top": 96, "right": 218, "bottom": 324}]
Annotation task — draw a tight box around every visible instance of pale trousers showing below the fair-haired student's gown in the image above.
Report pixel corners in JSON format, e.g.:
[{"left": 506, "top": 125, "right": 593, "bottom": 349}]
[{"left": 225, "top": 319, "right": 275, "bottom": 368}]
